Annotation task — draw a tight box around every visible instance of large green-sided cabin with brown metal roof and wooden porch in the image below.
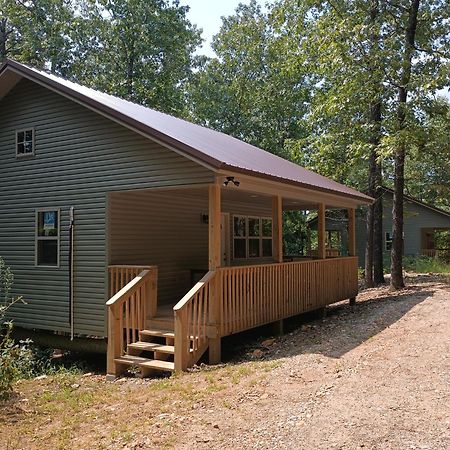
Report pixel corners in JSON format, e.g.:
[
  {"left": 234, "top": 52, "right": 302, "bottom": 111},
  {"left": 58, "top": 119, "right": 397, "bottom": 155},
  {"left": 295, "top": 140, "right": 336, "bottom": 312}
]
[{"left": 0, "top": 60, "right": 372, "bottom": 377}]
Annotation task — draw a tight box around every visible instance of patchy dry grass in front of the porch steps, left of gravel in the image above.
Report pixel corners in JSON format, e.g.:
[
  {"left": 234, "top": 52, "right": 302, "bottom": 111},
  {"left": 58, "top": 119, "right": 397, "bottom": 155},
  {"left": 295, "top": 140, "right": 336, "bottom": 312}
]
[{"left": 0, "top": 360, "right": 283, "bottom": 450}]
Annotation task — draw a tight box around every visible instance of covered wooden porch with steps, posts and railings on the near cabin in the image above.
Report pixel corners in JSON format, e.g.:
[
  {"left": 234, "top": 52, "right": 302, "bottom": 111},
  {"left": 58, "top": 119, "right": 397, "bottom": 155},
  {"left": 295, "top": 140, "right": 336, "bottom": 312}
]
[{"left": 107, "top": 177, "right": 358, "bottom": 376}]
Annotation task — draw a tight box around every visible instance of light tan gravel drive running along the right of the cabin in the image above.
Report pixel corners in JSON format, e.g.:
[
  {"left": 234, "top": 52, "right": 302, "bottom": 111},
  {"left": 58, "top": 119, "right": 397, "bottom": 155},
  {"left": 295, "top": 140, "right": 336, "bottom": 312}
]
[{"left": 178, "top": 280, "right": 450, "bottom": 450}]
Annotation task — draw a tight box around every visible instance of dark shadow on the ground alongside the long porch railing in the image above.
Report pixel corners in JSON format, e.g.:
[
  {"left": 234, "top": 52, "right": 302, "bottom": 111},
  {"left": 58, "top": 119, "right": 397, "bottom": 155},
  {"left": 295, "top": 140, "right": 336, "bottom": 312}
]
[{"left": 222, "top": 280, "right": 442, "bottom": 363}]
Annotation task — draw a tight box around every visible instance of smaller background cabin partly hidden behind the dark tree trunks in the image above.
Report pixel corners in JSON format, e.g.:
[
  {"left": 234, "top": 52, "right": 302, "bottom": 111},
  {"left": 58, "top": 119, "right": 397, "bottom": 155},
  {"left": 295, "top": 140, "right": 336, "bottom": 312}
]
[{"left": 306, "top": 187, "right": 450, "bottom": 267}]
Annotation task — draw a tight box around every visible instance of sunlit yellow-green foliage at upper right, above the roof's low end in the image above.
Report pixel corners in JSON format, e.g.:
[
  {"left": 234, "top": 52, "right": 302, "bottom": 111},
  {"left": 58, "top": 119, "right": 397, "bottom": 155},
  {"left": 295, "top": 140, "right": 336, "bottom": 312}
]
[{"left": 272, "top": 0, "right": 450, "bottom": 192}]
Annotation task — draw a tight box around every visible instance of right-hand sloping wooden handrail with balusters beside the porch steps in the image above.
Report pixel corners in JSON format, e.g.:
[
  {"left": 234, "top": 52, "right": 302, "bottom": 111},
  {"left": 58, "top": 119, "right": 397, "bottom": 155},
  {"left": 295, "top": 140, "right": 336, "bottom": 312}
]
[{"left": 173, "top": 271, "right": 216, "bottom": 371}]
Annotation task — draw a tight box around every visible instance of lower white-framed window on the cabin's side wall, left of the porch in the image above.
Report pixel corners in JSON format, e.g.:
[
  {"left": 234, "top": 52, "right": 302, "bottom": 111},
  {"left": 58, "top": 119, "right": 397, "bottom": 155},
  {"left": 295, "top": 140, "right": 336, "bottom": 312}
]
[{"left": 36, "top": 209, "right": 59, "bottom": 267}]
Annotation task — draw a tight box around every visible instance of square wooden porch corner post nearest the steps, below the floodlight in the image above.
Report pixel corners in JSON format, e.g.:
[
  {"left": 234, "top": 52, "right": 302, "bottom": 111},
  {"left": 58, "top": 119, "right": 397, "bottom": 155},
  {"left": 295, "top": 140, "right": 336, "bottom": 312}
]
[{"left": 208, "top": 183, "right": 222, "bottom": 364}]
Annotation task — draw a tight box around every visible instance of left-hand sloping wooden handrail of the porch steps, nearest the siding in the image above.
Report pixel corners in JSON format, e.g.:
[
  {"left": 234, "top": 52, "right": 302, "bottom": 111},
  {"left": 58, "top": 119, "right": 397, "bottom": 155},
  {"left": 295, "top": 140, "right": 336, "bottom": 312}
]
[{"left": 106, "top": 266, "right": 158, "bottom": 375}]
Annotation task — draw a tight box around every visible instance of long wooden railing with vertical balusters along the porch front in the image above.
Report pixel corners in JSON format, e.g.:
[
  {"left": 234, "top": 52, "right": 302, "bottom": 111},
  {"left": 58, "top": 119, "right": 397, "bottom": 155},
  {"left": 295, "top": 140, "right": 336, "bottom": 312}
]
[{"left": 217, "top": 257, "right": 358, "bottom": 336}]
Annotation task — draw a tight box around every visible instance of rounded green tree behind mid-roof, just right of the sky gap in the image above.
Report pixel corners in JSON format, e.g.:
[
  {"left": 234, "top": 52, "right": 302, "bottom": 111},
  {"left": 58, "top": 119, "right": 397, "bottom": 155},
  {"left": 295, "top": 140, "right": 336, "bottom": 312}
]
[{"left": 189, "top": 1, "right": 310, "bottom": 154}]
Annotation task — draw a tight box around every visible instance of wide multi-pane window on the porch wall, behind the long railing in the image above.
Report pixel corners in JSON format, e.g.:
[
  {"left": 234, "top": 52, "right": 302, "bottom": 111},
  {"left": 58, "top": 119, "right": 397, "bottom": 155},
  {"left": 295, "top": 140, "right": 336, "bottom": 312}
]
[{"left": 233, "top": 216, "right": 272, "bottom": 259}]
